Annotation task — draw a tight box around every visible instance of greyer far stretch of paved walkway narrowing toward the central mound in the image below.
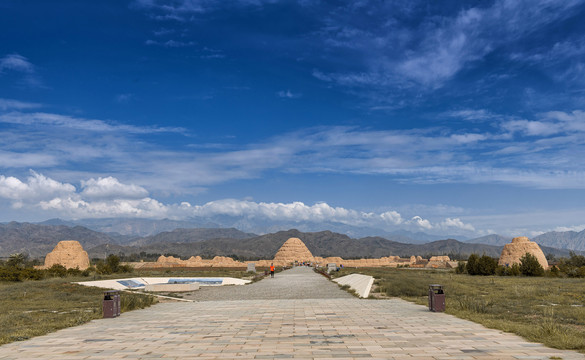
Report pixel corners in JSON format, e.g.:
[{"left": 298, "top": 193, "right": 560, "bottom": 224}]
[{"left": 183, "top": 266, "right": 354, "bottom": 301}]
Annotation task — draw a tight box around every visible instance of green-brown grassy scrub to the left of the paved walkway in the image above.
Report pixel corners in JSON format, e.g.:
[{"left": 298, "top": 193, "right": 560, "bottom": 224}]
[{"left": 0, "top": 278, "right": 156, "bottom": 344}]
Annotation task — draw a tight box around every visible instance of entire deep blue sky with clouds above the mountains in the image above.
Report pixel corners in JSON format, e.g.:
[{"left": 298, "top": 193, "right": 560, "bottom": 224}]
[{"left": 0, "top": 0, "right": 585, "bottom": 236}]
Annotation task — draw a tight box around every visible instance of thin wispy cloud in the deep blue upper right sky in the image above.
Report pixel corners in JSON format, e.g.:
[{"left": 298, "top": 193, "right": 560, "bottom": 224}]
[{"left": 313, "top": 0, "right": 582, "bottom": 91}]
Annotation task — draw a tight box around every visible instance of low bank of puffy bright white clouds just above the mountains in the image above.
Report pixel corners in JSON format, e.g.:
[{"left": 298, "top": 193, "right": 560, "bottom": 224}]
[{"left": 0, "top": 172, "right": 474, "bottom": 231}]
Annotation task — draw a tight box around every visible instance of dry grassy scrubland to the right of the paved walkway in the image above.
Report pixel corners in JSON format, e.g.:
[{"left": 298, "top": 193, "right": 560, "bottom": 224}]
[{"left": 344, "top": 268, "right": 585, "bottom": 352}]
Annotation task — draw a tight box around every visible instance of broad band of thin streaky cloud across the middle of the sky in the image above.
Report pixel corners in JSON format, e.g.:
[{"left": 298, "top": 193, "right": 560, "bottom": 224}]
[{"left": 0, "top": 105, "right": 585, "bottom": 193}]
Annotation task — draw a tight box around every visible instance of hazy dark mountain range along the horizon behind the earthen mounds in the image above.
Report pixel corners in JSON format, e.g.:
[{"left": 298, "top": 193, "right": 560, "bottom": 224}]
[{"left": 0, "top": 220, "right": 585, "bottom": 259}]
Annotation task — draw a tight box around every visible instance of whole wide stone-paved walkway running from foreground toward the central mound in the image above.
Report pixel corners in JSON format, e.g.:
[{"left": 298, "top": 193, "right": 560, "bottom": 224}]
[{"left": 0, "top": 268, "right": 585, "bottom": 360}]
